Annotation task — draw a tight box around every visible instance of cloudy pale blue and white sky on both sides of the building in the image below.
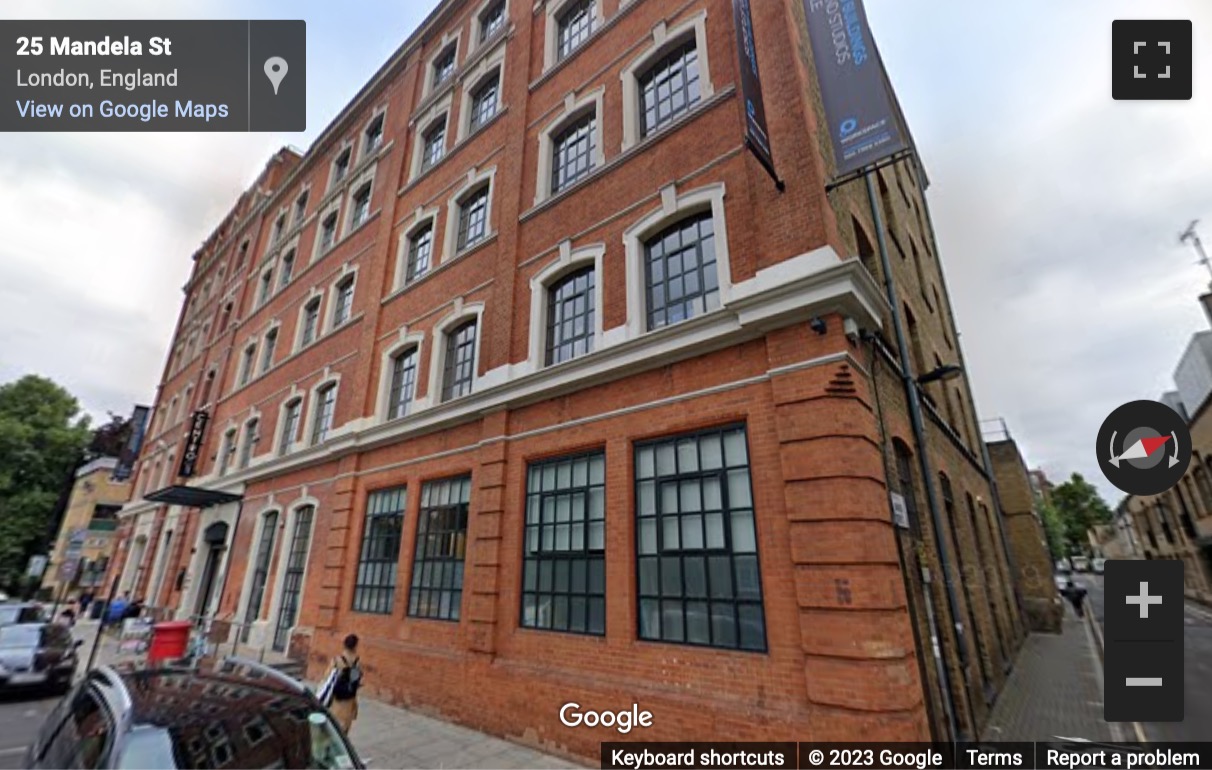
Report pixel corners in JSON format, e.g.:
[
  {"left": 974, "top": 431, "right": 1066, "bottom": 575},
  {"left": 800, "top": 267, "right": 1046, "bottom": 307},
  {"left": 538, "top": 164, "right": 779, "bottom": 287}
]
[{"left": 0, "top": 0, "right": 1212, "bottom": 504}]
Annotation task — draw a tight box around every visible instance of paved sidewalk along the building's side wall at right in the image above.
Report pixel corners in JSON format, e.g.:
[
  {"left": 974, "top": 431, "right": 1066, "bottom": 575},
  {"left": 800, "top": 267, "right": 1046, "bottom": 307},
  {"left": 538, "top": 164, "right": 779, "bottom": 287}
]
[{"left": 982, "top": 606, "right": 1124, "bottom": 741}]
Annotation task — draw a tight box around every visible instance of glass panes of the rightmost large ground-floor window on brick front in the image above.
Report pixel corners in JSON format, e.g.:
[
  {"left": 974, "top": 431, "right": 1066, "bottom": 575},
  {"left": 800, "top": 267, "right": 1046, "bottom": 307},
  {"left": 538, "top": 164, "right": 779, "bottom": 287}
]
[{"left": 635, "top": 426, "right": 766, "bottom": 650}]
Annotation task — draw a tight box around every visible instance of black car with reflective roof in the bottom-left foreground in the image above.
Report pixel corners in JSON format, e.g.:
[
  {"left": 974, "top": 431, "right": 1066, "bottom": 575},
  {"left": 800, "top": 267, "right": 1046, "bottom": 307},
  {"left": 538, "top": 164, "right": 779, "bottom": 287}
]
[{"left": 23, "top": 658, "right": 366, "bottom": 770}]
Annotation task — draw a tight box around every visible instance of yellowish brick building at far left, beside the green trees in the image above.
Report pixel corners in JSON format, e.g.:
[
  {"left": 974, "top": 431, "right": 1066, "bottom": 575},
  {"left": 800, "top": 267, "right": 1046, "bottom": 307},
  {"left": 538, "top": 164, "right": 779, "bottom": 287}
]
[{"left": 42, "top": 457, "right": 131, "bottom": 599}]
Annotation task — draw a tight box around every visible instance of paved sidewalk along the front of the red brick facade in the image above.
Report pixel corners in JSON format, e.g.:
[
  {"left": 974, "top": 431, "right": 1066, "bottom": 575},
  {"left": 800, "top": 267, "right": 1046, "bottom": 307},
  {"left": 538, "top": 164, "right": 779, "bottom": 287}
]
[{"left": 74, "top": 621, "right": 584, "bottom": 770}]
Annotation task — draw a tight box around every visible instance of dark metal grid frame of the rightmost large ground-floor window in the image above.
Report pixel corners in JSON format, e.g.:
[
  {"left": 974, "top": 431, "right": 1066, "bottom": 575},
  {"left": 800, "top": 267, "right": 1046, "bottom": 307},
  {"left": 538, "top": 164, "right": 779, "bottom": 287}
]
[{"left": 631, "top": 422, "right": 770, "bottom": 654}]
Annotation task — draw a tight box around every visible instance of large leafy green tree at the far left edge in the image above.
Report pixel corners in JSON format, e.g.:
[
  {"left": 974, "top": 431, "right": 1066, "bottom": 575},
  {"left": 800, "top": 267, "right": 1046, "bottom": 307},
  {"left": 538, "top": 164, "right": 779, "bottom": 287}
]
[{"left": 0, "top": 375, "right": 92, "bottom": 587}]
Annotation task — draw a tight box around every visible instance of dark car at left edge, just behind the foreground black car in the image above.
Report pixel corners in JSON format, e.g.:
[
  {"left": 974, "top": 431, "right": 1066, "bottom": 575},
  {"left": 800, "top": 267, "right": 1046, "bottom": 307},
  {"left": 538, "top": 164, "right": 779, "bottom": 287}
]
[{"left": 0, "top": 623, "right": 82, "bottom": 692}]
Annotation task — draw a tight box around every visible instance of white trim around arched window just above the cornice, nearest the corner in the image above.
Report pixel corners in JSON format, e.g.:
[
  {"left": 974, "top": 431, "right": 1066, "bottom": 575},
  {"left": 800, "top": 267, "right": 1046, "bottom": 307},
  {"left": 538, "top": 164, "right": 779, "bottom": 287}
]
[{"left": 623, "top": 182, "right": 732, "bottom": 340}]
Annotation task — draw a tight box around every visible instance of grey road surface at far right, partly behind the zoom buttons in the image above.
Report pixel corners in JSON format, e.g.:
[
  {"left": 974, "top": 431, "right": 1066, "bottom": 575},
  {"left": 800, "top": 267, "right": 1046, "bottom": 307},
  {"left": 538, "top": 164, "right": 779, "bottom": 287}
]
[{"left": 1081, "top": 575, "right": 1212, "bottom": 742}]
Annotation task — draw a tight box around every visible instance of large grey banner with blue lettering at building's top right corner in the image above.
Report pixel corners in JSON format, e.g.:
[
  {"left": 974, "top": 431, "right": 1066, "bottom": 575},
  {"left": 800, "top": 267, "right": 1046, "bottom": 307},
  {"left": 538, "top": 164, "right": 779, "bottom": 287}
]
[{"left": 804, "top": 0, "right": 910, "bottom": 176}]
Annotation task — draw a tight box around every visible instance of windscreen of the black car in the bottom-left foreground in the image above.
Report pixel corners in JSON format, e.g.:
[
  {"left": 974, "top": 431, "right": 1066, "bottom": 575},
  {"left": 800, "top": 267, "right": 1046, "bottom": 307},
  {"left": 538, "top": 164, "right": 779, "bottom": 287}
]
[{"left": 118, "top": 709, "right": 358, "bottom": 770}]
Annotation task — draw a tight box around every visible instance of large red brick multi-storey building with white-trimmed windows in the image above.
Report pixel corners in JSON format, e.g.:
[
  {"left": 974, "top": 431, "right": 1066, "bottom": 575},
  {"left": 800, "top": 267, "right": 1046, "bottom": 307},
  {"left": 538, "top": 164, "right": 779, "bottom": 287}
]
[{"left": 114, "top": 0, "right": 1023, "bottom": 755}]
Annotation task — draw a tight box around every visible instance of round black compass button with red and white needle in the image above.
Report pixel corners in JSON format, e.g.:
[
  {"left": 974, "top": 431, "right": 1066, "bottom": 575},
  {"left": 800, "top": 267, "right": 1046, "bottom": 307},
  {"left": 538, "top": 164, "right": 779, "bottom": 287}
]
[{"left": 1094, "top": 401, "right": 1191, "bottom": 495}]
